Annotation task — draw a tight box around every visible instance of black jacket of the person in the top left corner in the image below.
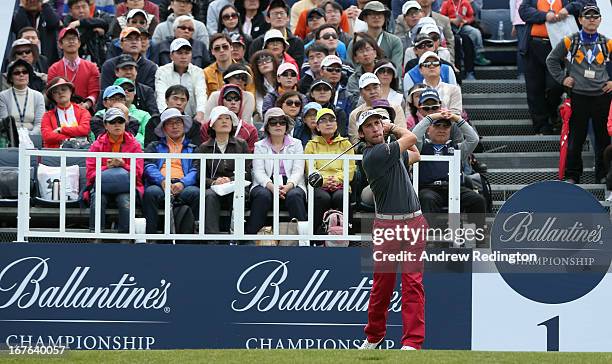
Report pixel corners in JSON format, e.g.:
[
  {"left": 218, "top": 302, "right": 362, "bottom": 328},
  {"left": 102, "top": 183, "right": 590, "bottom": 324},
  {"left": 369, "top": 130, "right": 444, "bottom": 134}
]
[{"left": 10, "top": 3, "right": 60, "bottom": 64}]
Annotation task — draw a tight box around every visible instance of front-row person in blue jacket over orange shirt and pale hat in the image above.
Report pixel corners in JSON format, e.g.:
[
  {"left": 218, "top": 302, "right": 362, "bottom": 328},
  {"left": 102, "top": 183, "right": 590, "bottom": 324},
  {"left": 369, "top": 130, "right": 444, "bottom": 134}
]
[{"left": 142, "top": 108, "right": 200, "bottom": 234}]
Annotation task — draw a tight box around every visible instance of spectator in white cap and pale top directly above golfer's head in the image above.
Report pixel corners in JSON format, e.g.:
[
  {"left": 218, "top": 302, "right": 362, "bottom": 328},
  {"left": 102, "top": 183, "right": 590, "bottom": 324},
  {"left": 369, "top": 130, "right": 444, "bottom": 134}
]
[{"left": 348, "top": 72, "right": 406, "bottom": 143}]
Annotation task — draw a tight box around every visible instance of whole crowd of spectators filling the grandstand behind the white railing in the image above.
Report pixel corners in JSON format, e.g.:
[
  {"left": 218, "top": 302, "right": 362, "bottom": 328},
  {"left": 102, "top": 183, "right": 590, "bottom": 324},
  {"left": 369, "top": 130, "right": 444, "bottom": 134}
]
[{"left": 0, "top": 0, "right": 608, "bottom": 240}]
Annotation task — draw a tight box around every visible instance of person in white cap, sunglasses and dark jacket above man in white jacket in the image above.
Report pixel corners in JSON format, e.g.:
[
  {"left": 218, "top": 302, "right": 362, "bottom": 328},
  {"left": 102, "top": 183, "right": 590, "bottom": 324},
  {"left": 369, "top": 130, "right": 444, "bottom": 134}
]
[{"left": 151, "top": 15, "right": 211, "bottom": 68}]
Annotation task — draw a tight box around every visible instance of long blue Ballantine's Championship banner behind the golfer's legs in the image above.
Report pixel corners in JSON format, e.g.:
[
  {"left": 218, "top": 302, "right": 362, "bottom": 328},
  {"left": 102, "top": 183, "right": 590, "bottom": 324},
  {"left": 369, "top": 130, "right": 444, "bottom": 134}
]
[{"left": 0, "top": 243, "right": 472, "bottom": 349}]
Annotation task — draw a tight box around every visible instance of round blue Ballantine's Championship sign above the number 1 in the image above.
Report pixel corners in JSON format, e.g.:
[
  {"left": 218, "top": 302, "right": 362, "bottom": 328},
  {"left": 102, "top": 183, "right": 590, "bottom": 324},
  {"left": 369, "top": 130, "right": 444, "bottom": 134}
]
[{"left": 491, "top": 181, "right": 612, "bottom": 304}]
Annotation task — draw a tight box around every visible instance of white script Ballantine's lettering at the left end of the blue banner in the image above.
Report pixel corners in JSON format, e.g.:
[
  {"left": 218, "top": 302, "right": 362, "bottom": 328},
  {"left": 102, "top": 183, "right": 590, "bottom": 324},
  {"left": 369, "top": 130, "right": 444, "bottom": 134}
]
[{"left": 0, "top": 257, "right": 171, "bottom": 309}]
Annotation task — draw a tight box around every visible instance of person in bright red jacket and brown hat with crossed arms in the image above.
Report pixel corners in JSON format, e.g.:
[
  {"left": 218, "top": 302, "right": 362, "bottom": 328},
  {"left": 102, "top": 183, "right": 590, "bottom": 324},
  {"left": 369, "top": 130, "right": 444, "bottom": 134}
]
[{"left": 40, "top": 77, "right": 91, "bottom": 148}]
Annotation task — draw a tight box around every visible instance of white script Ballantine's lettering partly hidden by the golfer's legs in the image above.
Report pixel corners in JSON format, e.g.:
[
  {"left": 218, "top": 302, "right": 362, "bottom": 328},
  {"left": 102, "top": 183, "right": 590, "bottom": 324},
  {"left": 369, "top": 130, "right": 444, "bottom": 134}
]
[{"left": 232, "top": 260, "right": 401, "bottom": 312}]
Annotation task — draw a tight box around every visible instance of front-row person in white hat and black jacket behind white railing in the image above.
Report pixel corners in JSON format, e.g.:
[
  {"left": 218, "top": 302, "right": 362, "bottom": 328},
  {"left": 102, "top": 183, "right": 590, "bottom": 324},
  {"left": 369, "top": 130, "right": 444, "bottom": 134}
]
[{"left": 197, "top": 106, "right": 251, "bottom": 234}]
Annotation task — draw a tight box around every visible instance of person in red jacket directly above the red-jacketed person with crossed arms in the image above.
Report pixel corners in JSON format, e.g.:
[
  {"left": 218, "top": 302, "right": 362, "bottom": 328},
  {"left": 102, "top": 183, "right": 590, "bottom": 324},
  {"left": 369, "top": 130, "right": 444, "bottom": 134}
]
[{"left": 48, "top": 28, "right": 100, "bottom": 111}]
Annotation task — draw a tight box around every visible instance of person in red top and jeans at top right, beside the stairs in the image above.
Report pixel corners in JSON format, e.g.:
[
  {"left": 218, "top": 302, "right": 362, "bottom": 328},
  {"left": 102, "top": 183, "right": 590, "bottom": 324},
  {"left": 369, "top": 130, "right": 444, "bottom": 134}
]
[{"left": 440, "top": 0, "right": 491, "bottom": 66}]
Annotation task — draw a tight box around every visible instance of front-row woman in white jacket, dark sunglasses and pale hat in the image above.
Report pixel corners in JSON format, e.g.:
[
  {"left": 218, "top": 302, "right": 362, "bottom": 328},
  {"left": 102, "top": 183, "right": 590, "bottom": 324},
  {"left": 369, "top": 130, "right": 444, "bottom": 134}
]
[{"left": 245, "top": 107, "right": 308, "bottom": 234}]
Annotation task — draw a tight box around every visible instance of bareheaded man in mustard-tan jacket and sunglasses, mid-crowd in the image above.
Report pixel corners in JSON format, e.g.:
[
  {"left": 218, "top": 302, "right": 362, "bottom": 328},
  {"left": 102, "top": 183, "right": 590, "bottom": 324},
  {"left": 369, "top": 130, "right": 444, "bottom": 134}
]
[{"left": 204, "top": 33, "right": 235, "bottom": 96}]
